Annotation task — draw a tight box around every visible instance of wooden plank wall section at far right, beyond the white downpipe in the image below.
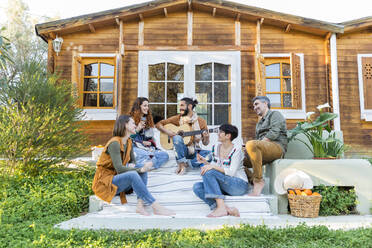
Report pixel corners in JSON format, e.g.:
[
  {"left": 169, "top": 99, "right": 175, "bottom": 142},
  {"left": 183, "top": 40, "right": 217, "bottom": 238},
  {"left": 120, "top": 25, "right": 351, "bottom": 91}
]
[{"left": 337, "top": 29, "right": 372, "bottom": 155}]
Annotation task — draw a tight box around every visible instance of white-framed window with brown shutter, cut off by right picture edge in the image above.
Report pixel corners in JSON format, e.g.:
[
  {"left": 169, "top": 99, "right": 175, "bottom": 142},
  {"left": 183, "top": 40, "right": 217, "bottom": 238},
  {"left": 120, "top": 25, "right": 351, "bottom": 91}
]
[{"left": 358, "top": 54, "right": 372, "bottom": 121}]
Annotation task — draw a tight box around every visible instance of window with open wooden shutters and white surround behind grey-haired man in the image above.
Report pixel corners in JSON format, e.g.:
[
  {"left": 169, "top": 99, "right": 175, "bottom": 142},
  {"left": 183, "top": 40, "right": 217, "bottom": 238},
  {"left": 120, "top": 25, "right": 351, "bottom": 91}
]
[{"left": 256, "top": 53, "right": 306, "bottom": 119}]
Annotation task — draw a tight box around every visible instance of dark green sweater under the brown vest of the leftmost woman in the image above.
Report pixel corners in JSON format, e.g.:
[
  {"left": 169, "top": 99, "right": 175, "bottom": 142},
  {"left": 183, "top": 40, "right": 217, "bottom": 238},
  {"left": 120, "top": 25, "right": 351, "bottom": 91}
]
[{"left": 107, "top": 141, "right": 141, "bottom": 174}]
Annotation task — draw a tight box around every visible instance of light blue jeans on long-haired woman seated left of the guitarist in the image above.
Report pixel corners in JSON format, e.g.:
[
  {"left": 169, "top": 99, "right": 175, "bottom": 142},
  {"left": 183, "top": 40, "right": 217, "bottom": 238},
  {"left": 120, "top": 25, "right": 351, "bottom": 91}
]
[{"left": 133, "top": 147, "right": 169, "bottom": 169}]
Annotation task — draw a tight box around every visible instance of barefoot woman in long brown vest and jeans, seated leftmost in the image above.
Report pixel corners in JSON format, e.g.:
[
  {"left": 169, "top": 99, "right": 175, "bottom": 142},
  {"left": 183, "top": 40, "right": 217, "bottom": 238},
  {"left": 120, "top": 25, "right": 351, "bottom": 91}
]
[{"left": 92, "top": 115, "right": 175, "bottom": 215}]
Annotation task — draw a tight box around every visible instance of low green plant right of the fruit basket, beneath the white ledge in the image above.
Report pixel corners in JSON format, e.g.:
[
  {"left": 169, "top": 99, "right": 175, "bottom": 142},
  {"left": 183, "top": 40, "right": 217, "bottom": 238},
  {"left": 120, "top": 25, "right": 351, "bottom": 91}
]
[{"left": 313, "top": 185, "right": 357, "bottom": 216}]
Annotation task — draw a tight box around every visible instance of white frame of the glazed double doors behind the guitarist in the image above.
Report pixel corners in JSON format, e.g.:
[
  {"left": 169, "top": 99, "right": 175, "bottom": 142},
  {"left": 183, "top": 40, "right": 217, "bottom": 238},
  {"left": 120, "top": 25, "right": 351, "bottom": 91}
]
[{"left": 138, "top": 51, "right": 241, "bottom": 135}]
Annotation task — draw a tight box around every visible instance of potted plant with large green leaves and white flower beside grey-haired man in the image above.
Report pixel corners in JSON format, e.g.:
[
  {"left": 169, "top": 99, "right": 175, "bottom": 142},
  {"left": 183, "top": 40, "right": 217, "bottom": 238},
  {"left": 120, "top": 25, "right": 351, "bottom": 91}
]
[{"left": 289, "top": 103, "right": 345, "bottom": 158}]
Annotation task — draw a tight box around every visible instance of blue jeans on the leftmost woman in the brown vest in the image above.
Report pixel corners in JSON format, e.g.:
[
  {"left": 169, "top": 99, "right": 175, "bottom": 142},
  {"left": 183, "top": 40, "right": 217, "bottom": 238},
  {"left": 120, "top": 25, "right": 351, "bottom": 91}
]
[{"left": 112, "top": 171, "right": 155, "bottom": 205}]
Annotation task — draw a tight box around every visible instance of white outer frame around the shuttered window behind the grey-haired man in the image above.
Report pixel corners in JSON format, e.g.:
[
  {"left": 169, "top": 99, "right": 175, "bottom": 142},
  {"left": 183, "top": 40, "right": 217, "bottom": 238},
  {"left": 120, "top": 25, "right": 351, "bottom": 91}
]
[{"left": 261, "top": 53, "right": 306, "bottom": 119}]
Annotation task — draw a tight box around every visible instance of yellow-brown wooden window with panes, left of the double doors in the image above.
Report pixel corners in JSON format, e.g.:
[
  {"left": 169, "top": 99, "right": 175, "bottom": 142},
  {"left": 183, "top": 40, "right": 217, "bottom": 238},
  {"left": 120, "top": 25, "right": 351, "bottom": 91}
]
[{"left": 79, "top": 58, "right": 116, "bottom": 109}]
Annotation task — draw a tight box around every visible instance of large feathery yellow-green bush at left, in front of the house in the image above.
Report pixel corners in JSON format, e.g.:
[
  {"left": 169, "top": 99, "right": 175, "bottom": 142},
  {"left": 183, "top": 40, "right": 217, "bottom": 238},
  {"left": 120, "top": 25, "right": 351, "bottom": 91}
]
[{"left": 0, "top": 61, "right": 88, "bottom": 175}]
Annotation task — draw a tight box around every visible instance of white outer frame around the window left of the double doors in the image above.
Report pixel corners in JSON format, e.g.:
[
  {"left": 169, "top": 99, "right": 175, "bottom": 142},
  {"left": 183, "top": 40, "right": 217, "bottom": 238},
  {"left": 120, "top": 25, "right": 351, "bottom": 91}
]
[{"left": 79, "top": 53, "right": 119, "bottom": 121}]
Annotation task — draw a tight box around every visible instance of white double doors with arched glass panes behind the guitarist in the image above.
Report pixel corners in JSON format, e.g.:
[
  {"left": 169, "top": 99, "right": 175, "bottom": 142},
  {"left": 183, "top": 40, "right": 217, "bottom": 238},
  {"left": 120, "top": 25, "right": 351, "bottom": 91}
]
[{"left": 138, "top": 51, "right": 241, "bottom": 131}]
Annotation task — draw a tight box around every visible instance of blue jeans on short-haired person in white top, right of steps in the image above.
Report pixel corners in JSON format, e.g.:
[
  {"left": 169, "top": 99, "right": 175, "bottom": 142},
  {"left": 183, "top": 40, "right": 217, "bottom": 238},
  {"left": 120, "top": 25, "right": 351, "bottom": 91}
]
[{"left": 193, "top": 169, "right": 251, "bottom": 210}]
